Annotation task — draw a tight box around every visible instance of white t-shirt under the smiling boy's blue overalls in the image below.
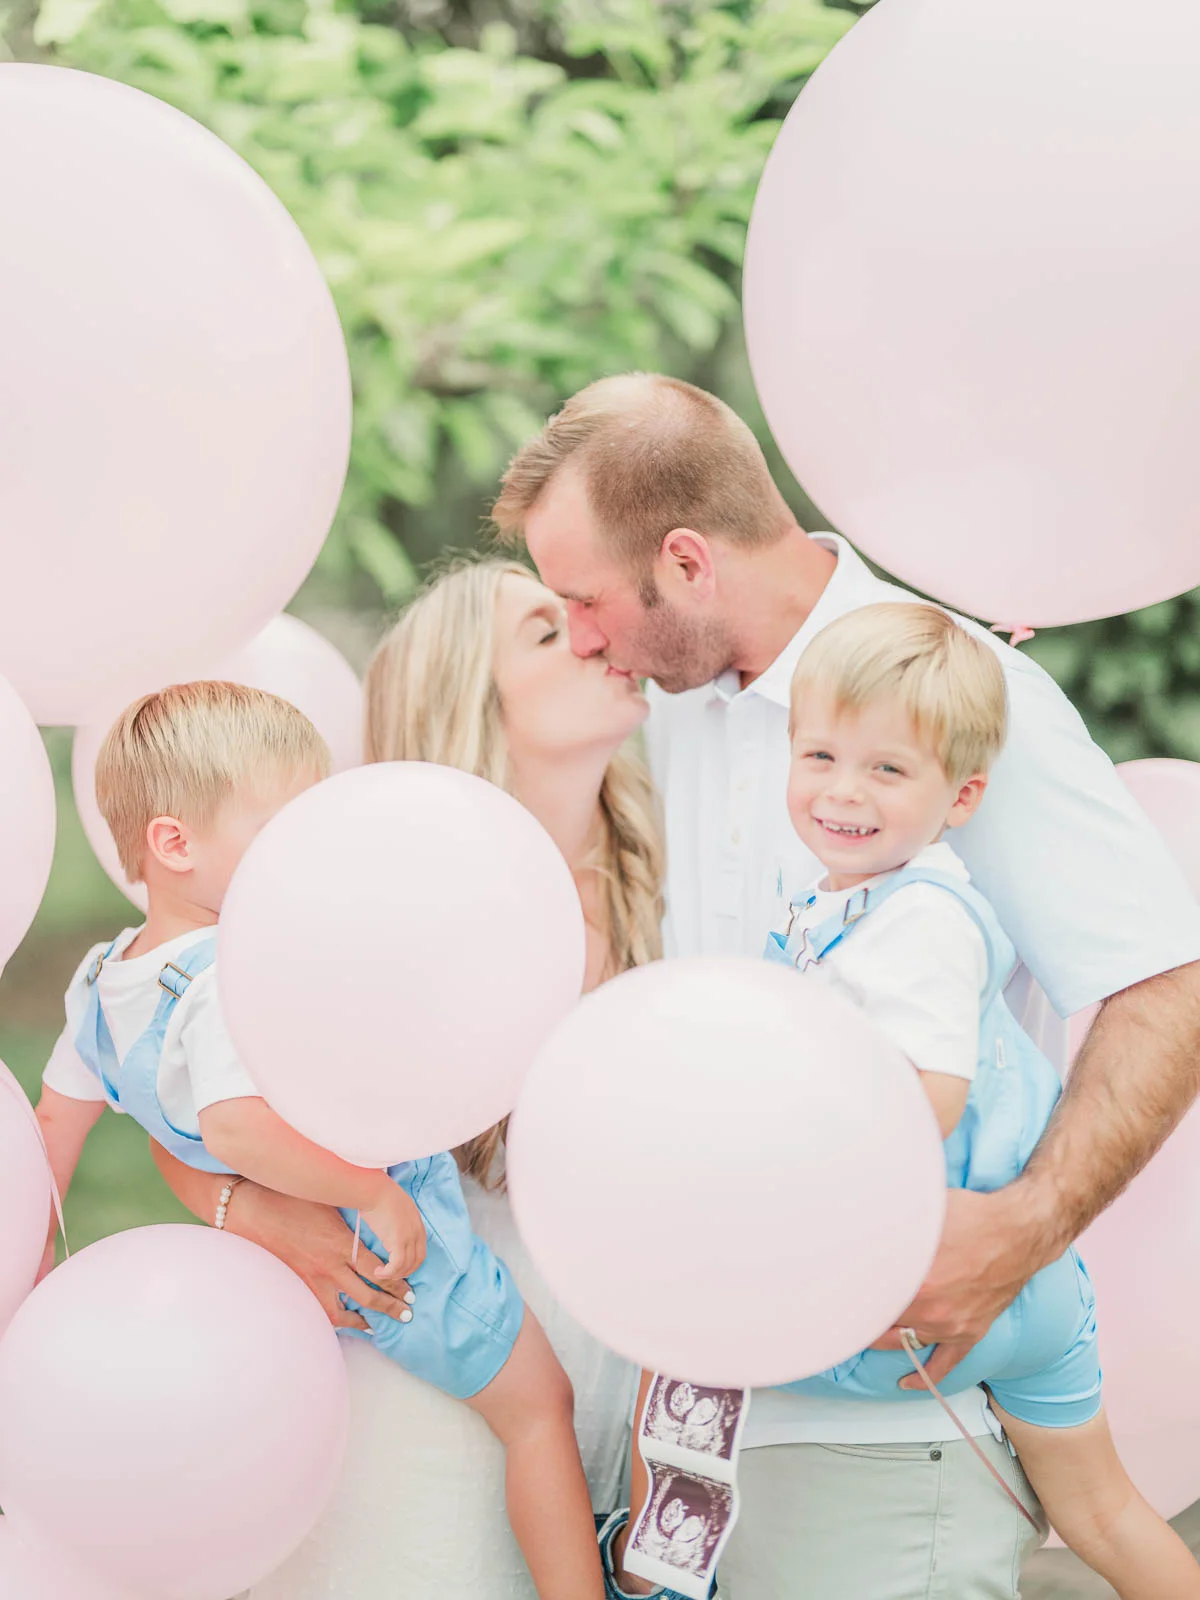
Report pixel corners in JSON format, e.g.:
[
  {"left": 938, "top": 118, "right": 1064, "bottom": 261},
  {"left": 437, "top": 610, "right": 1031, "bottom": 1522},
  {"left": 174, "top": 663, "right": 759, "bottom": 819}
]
[{"left": 779, "top": 842, "right": 987, "bottom": 1078}]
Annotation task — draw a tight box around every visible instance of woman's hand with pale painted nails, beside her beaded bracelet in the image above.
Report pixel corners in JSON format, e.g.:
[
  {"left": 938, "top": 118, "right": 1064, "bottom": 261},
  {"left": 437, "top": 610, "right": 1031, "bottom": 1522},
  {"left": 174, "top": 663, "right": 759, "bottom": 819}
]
[{"left": 226, "top": 1182, "right": 408, "bottom": 1330}]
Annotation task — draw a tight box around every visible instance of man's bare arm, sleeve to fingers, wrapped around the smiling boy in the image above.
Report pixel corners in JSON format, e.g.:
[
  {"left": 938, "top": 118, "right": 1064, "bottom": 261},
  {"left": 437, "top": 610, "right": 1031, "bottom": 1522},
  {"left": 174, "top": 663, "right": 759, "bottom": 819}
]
[{"left": 883, "top": 962, "right": 1200, "bottom": 1389}]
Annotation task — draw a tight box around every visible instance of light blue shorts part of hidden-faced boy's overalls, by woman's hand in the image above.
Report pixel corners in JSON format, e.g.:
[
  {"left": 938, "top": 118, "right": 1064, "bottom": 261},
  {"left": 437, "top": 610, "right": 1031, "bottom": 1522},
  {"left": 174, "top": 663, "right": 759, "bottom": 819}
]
[{"left": 342, "top": 1154, "right": 525, "bottom": 1400}]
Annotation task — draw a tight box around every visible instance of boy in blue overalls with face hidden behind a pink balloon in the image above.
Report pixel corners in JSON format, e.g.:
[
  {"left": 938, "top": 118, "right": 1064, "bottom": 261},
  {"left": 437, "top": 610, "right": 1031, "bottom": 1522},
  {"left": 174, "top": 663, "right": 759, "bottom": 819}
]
[{"left": 38, "top": 683, "right": 603, "bottom": 1600}]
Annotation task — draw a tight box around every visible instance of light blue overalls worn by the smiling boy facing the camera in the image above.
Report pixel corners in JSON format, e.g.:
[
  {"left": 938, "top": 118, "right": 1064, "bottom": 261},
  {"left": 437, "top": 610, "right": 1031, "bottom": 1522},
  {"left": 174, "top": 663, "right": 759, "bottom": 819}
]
[{"left": 765, "top": 867, "right": 1101, "bottom": 1427}]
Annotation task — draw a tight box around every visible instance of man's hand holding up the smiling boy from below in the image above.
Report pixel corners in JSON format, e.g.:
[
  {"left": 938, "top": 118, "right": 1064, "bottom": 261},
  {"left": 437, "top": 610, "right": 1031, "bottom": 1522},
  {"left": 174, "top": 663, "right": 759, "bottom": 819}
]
[{"left": 874, "top": 1181, "right": 1054, "bottom": 1389}]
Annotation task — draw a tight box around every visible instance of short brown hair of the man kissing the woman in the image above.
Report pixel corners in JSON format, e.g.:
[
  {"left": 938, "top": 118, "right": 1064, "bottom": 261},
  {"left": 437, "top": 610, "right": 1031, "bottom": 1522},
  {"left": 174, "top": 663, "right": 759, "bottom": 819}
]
[{"left": 491, "top": 373, "right": 794, "bottom": 571}]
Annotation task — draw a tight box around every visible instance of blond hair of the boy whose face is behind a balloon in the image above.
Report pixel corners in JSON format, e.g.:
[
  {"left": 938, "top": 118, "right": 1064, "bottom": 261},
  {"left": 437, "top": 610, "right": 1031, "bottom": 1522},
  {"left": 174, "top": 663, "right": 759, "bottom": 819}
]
[{"left": 96, "top": 682, "right": 331, "bottom": 883}]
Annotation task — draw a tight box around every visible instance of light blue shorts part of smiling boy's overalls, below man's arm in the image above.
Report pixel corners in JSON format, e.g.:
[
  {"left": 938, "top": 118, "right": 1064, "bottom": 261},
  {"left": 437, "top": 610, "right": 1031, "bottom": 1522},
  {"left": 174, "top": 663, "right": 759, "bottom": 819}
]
[{"left": 782, "top": 1250, "right": 1101, "bottom": 1427}]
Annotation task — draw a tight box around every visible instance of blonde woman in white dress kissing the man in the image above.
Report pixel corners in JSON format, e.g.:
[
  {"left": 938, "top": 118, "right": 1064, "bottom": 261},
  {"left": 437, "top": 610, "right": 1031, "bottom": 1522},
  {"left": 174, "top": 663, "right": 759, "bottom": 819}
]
[{"left": 157, "top": 560, "right": 662, "bottom": 1600}]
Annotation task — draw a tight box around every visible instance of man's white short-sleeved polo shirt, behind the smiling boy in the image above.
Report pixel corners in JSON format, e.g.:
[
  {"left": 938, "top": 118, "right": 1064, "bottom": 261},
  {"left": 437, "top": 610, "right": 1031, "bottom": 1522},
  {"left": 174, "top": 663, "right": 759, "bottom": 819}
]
[{"left": 646, "top": 534, "right": 1200, "bottom": 1446}]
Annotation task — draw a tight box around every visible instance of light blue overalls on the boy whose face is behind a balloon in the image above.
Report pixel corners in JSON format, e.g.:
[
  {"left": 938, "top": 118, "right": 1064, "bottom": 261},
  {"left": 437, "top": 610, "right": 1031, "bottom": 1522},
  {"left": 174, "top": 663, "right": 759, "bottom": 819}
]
[{"left": 75, "top": 930, "right": 525, "bottom": 1400}]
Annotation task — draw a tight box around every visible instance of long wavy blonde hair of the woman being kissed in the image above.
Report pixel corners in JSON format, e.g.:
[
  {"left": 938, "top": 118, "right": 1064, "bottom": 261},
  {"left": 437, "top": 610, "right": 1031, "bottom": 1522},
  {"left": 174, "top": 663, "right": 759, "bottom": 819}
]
[{"left": 365, "top": 560, "right": 664, "bottom": 1187}]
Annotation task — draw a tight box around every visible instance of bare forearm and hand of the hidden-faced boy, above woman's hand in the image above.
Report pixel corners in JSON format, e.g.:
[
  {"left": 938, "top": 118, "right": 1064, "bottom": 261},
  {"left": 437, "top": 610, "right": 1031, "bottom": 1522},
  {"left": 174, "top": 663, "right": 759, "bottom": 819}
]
[{"left": 200, "top": 1096, "right": 426, "bottom": 1288}]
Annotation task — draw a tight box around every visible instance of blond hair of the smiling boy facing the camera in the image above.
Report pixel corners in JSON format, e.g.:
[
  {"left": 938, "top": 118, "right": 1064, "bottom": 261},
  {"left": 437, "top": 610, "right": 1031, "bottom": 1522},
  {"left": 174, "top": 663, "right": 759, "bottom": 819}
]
[{"left": 792, "top": 600, "right": 1008, "bottom": 784}]
